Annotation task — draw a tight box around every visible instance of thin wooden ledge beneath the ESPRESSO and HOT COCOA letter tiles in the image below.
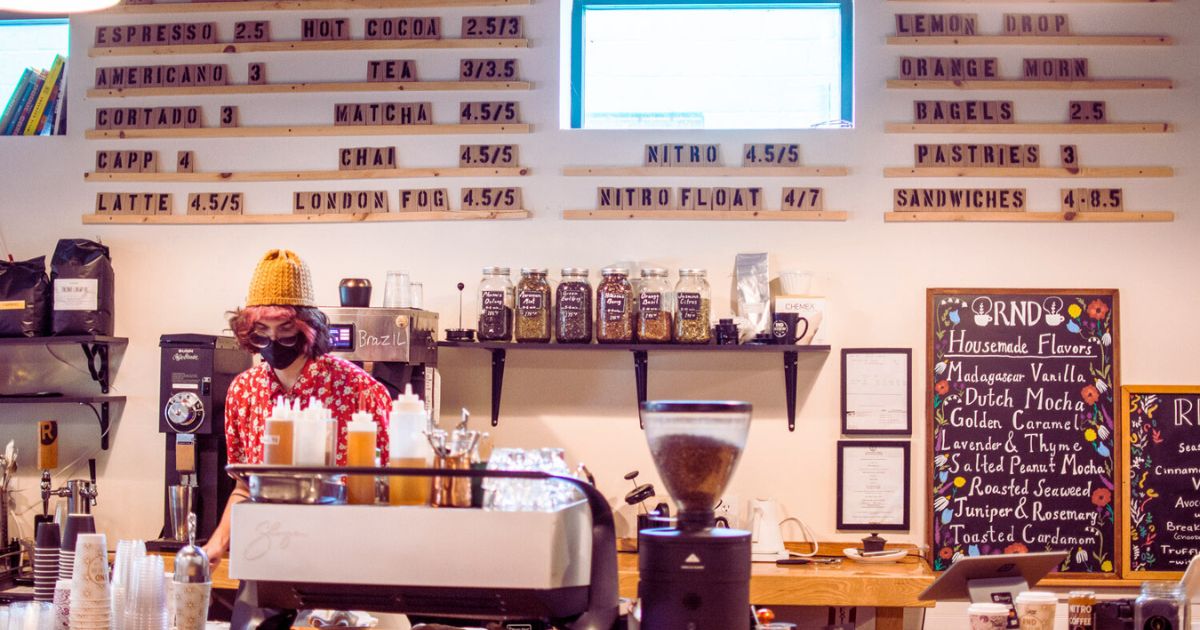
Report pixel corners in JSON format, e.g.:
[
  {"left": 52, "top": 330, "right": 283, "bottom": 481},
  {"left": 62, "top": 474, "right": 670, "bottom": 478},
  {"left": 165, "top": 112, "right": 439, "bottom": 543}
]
[{"left": 88, "top": 38, "right": 529, "bottom": 56}]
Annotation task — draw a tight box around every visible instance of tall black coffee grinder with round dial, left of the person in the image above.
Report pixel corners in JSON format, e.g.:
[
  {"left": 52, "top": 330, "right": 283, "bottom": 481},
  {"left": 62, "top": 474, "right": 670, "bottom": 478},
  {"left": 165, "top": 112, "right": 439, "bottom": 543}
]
[{"left": 146, "top": 335, "right": 252, "bottom": 551}]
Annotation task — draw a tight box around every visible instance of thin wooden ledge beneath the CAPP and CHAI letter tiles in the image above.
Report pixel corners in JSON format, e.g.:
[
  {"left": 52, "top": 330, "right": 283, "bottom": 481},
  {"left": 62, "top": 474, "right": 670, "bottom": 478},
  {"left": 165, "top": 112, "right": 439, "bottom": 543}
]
[{"left": 83, "top": 167, "right": 529, "bottom": 182}]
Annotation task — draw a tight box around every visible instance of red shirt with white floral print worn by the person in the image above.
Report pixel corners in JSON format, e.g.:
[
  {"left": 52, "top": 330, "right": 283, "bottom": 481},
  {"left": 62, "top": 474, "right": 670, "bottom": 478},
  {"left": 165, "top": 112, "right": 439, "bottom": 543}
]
[{"left": 226, "top": 354, "right": 391, "bottom": 466}]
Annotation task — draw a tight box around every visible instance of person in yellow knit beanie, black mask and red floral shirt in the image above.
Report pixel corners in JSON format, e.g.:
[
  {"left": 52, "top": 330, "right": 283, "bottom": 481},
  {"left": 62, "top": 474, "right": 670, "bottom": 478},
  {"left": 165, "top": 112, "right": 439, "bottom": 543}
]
[{"left": 204, "top": 250, "right": 390, "bottom": 566}]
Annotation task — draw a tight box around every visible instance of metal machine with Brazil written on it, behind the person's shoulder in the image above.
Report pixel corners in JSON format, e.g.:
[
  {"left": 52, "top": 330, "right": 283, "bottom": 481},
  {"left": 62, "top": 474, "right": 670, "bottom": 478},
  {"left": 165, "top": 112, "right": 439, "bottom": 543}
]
[{"left": 320, "top": 306, "right": 440, "bottom": 418}]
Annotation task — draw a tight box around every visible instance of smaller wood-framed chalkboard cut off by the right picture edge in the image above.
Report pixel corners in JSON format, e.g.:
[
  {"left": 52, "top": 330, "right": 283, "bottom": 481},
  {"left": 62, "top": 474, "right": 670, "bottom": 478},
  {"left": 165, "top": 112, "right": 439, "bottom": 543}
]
[{"left": 1121, "top": 385, "right": 1200, "bottom": 578}]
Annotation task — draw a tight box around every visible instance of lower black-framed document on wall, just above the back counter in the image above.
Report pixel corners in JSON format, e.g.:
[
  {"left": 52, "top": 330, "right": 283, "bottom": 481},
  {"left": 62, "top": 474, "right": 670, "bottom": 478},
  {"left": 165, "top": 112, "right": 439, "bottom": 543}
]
[{"left": 838, "top": 440, "right": 911, "bottom": 532}]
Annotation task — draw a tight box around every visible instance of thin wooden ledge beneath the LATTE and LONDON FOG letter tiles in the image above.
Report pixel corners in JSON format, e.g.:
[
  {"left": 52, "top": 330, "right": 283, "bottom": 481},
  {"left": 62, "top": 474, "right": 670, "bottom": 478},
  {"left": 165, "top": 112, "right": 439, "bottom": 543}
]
[{"left": 83, "top": 210, "right": 529, "bottom": 226}]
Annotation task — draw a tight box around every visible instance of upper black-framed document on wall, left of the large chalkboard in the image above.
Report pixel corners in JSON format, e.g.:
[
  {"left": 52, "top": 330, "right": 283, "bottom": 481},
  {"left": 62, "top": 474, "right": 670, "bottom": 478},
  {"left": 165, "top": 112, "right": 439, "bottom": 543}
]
[{"left": 841, "top": 348, "right": 912, "bottom": 436}]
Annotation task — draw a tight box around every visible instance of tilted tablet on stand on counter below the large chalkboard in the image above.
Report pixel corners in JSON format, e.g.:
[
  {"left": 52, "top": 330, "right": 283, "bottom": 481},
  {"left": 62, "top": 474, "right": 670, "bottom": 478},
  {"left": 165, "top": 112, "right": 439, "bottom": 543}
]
[{"left": 918, "top": 551, "right": 1067, "bottom": 628}]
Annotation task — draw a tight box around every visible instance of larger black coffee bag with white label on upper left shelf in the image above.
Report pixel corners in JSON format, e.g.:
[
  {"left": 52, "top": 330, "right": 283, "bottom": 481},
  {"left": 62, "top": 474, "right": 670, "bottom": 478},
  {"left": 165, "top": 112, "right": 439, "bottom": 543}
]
[{"left": 50, "top": 239, "right": 114, "bottom": 335}]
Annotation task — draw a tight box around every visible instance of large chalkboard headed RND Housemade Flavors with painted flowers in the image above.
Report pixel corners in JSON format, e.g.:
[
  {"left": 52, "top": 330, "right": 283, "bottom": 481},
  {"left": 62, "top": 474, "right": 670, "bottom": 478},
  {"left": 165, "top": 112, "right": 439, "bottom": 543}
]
[{"left": 925, "top": 289, "right": 1121, "bottom": 577}]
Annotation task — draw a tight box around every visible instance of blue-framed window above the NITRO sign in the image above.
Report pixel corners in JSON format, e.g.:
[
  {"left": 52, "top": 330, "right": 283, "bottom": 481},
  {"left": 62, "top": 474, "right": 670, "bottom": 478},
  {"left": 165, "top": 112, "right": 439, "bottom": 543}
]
[{"left": 564, "top": 0, "right": 853, "bottom": 128}]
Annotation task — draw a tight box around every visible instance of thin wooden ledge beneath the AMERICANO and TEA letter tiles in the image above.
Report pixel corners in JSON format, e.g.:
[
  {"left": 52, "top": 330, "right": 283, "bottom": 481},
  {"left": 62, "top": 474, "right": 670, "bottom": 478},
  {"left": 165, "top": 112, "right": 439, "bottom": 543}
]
[{"left": 88, "top": 80, "right": 529, "bottom": 98}]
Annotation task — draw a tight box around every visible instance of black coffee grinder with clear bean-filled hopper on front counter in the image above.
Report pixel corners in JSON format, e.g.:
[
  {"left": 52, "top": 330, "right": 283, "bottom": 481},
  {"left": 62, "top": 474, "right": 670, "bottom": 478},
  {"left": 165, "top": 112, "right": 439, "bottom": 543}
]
[{"left": 637, "top": 401, "right": 750, "bottom": 630}]
